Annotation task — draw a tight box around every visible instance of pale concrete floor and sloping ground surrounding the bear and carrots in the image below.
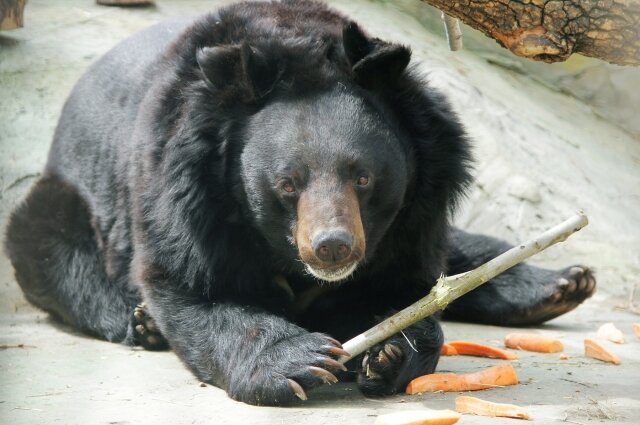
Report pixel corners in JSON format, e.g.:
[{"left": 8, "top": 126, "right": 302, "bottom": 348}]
[{"left": 0, "top": 0, "right": 640, "bottom": 425}]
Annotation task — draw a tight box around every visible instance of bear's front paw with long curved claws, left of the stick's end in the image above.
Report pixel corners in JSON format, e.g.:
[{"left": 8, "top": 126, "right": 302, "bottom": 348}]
[{"left": 229, "top": 333, "right": 349, "bottom": 406}]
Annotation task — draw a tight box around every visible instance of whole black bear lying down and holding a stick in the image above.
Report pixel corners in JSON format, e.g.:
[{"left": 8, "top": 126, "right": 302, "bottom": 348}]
[{"left": 6, "top": 0, "right": 595, "bottom": 405}]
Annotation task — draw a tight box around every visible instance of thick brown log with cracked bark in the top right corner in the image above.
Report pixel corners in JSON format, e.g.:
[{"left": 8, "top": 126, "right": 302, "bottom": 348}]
[{"left": 422, "top": 0, "right": 640, "bottom": 65}]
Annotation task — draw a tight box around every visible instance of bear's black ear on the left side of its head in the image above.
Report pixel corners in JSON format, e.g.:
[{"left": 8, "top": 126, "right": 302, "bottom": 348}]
[{"left": 196, "top": 43, "right": 280, "bottom": 100}]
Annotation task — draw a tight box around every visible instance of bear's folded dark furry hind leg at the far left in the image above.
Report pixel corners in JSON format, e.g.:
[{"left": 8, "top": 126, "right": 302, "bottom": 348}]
[{"left": 6, "top": 176, "right": 139, "bottom": 343}]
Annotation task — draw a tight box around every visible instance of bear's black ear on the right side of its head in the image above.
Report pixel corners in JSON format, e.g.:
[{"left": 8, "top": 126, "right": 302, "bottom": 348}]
[{"left": 342, "top": 22, "right": 411, "bottom": 87}]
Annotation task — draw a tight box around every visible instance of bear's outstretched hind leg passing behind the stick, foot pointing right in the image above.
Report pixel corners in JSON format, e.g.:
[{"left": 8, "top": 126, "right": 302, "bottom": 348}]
[{"left": 443, "top": 229, "right": 596, "bottom": 326}]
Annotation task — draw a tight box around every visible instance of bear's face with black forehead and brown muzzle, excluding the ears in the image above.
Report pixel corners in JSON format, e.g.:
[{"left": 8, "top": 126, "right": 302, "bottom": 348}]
[{"left": 240, "top": 86, "right": 411, "bottom": 281}]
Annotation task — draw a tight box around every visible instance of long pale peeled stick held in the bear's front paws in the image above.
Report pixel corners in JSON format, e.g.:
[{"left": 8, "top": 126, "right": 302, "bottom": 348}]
[{"left": 339, "top": 211, "right": 589, "bottom": 363}]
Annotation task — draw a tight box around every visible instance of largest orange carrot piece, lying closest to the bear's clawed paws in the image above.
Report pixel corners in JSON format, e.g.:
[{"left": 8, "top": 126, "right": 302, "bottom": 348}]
[{"left": 407, "top": 363, "right": 518, "bottom": 394}]
